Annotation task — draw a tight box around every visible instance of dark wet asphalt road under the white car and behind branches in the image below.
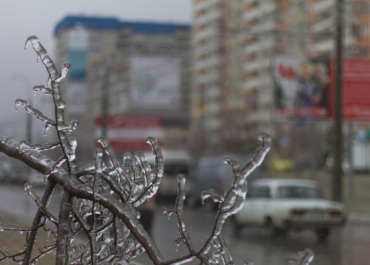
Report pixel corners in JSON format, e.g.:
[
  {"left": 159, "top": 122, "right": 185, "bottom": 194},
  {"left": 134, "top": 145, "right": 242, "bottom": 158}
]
[{"left": 0, "top": 186, "right": 370, "bottom": 265}]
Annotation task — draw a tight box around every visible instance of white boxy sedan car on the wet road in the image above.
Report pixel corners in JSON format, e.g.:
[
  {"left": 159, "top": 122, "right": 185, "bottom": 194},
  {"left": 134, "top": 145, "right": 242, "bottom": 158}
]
[{"left": 233, "top": 179, "right": 346, "bottom": 240}]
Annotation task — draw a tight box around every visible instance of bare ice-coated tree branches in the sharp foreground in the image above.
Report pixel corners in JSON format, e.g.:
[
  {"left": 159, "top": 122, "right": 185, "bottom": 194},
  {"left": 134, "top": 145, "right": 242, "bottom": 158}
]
[{"left": 0, "top": 36, "right": 313, "bottom": 265}]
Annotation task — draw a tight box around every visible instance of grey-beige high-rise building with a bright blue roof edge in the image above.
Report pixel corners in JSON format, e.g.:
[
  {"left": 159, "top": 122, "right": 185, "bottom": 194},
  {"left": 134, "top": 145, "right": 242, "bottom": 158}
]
[{"left": 55, "top": 16, "right": 191, "bottom": 161}]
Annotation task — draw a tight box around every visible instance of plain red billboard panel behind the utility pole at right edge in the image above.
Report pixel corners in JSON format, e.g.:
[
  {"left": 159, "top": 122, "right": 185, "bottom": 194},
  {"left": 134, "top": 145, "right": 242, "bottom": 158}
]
[{"left": 329, "top": 59, "right": 370, "bottom": 121}]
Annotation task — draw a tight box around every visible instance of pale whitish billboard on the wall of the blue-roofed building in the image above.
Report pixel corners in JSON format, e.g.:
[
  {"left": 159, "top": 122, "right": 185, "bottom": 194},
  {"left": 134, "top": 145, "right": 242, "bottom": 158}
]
[{"left": 131, "top": 56, "right": 181, "bottom": 109}]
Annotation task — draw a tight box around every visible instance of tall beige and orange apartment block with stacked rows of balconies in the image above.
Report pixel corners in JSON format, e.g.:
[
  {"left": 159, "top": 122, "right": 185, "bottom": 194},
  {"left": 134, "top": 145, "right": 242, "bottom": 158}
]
[{"left": 192, "top": 0, "right": 370, "bottom": 152}]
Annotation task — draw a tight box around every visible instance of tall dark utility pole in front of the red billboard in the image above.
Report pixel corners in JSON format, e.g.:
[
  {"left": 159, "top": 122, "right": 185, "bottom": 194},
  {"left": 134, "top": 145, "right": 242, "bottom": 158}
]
[{"left": 332, "top": 0, "right": 343, "bottom": 202}]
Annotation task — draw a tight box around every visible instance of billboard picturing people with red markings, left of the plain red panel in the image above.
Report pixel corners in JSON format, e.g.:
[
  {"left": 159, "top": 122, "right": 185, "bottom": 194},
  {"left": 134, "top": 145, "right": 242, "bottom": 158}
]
[{"left": 272, "top": 57, "right": 329, "bottom": 120}]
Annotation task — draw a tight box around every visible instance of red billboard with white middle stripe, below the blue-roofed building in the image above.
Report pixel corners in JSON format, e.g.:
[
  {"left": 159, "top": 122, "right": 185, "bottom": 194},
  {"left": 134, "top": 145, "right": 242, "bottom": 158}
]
[{"left": 95, "top": 115, "right": 163, "bottom": 152}]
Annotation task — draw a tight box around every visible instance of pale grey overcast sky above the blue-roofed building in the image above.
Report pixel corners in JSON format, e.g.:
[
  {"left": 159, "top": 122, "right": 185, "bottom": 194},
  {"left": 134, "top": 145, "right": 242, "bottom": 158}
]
[{"left": 0, "top": 0, "right": 192, "bottom": 137}]
